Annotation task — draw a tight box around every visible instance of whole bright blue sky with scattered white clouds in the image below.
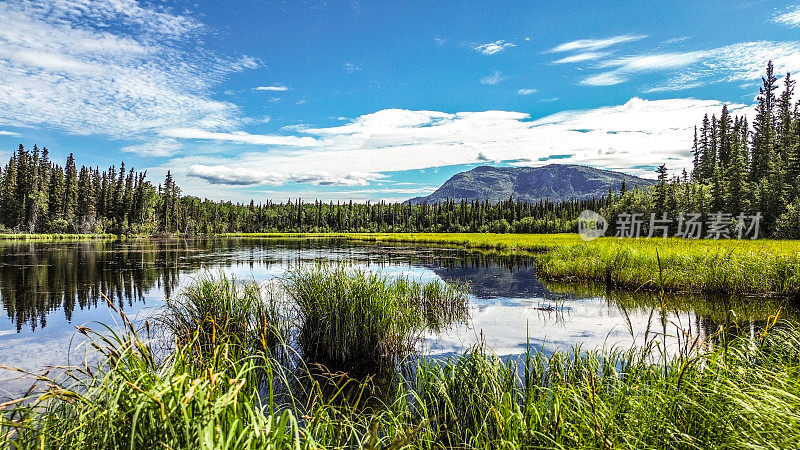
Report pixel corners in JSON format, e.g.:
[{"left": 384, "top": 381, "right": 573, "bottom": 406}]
[{"left": 0, "top": 0, "right": 800, "bottom": 201}]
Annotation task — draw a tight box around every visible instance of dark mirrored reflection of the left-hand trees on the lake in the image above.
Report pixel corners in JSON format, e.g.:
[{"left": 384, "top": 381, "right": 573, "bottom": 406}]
[{"left": 0, "top": 241, "right": 191, "bottom": 332}]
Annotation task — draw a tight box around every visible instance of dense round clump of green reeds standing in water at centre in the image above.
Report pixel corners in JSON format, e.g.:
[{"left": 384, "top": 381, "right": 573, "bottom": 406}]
[{"left": 286, "top": 266, "right": 468, "bottom": 370}]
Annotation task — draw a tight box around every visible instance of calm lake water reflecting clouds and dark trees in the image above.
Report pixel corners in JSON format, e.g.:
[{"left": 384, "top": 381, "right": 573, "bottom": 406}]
[{"left": 0, "top": 239, "right": 792, "bottom": 391}]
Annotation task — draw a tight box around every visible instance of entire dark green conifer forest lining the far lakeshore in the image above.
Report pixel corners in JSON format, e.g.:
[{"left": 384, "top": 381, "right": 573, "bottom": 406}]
[{"left": 0, "top": 62, "right": 800, "bottom": 238}]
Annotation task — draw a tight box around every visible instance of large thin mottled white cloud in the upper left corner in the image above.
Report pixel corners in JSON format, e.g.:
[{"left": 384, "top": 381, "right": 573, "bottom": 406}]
[{"left": 0, "top": 0, "right": 258, "bottom": 139}]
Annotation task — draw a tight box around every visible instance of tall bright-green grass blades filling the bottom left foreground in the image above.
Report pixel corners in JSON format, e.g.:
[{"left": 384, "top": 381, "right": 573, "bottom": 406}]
[{"left": 0, "top": 315, "right": 303, "bottom": 449}]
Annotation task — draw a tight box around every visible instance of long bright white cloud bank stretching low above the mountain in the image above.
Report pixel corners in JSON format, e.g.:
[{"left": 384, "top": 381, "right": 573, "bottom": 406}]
[{"left": 158, "top": 98, "right": 747, "bottom": 196}]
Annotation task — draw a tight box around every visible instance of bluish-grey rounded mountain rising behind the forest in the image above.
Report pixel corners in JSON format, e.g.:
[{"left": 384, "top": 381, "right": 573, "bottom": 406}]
[{"left": 409, "top": 164, "right": 655, "bottom": 204}]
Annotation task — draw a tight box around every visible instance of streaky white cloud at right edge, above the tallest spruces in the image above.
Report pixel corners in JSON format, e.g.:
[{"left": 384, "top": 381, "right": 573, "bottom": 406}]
[{"left": 581, "top": 41, "right": 800, "bottom": 88}]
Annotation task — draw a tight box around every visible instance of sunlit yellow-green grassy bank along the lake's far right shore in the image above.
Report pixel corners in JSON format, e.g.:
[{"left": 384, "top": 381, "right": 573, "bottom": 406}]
[{"left": 230, "top": 233, "right": 800, "bottom": 295}]
